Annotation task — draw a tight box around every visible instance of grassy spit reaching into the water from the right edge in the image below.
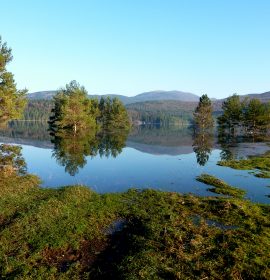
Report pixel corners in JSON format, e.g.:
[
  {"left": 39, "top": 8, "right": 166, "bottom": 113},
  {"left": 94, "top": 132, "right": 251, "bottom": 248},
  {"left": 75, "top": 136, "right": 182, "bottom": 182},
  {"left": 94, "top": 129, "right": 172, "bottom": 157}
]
[{"left": 218, "top": 151, "right": 270, "bottom": 178}]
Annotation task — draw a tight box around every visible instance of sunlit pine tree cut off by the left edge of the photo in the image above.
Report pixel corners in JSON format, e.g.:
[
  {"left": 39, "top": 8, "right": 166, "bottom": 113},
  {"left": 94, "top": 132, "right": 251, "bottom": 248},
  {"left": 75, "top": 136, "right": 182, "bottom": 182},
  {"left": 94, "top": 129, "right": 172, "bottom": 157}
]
[{"left": 0, "top": 37, "right": 27, "bottom": 124}]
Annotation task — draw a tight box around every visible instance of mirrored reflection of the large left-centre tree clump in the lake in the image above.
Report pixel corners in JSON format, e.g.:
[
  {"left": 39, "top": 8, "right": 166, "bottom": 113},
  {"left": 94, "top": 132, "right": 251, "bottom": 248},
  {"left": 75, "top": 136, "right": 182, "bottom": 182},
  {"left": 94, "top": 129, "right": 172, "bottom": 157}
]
[{"left": 51, "top": 131, "right": 128, "bottom": 176}]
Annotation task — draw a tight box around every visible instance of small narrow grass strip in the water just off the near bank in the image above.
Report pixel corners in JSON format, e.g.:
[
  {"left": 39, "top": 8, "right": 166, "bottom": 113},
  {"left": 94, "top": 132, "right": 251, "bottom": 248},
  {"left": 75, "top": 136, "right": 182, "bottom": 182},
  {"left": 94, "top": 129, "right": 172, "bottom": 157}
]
[{"left": 196, "top": 174, "right": 246, "bottom": 198}]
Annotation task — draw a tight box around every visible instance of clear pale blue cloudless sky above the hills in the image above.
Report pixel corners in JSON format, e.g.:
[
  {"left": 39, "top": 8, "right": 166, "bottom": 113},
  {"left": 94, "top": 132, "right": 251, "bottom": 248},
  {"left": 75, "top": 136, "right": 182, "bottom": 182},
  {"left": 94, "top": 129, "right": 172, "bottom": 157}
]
[{"left": 0, "top": 0, "right": 270, "bottom": 98}]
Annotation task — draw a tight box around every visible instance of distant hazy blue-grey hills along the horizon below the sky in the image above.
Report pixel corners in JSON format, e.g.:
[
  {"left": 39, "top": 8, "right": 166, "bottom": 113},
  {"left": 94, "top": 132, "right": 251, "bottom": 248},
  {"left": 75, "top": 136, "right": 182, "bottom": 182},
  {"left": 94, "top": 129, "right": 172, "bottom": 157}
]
[{"left": 28, "top": 90, "right": 199, "bottom": 104}]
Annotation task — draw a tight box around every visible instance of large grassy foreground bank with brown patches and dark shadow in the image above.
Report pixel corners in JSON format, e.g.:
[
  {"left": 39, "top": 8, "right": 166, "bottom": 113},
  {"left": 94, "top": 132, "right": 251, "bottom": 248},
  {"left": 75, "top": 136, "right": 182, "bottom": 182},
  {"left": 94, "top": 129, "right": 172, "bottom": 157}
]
[{"left": 0, "top": 175, "right": 270, "bottom": 279}]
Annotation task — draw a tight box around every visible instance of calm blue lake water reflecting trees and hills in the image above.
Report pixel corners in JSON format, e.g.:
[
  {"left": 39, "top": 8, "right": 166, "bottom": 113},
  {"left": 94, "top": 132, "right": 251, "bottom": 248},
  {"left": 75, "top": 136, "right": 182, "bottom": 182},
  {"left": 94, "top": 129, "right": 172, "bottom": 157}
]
[{"left": 0, "top": 122, "right": 270, "bottom": 203}]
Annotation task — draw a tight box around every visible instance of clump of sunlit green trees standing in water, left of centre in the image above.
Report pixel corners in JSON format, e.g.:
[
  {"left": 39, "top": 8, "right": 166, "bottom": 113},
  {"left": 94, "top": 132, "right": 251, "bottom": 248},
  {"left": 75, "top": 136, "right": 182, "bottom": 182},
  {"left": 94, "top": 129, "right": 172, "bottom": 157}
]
[{"left": 49, "top": 81, "right": 130, "bottom": 134}]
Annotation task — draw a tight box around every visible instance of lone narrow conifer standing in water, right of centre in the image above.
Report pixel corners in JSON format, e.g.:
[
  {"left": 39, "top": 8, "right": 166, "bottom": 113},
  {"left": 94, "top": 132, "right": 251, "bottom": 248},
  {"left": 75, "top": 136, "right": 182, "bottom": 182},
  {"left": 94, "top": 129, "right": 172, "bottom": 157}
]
[{"left": 194, "top": 94, "right": 214, "bottom": 131}]
